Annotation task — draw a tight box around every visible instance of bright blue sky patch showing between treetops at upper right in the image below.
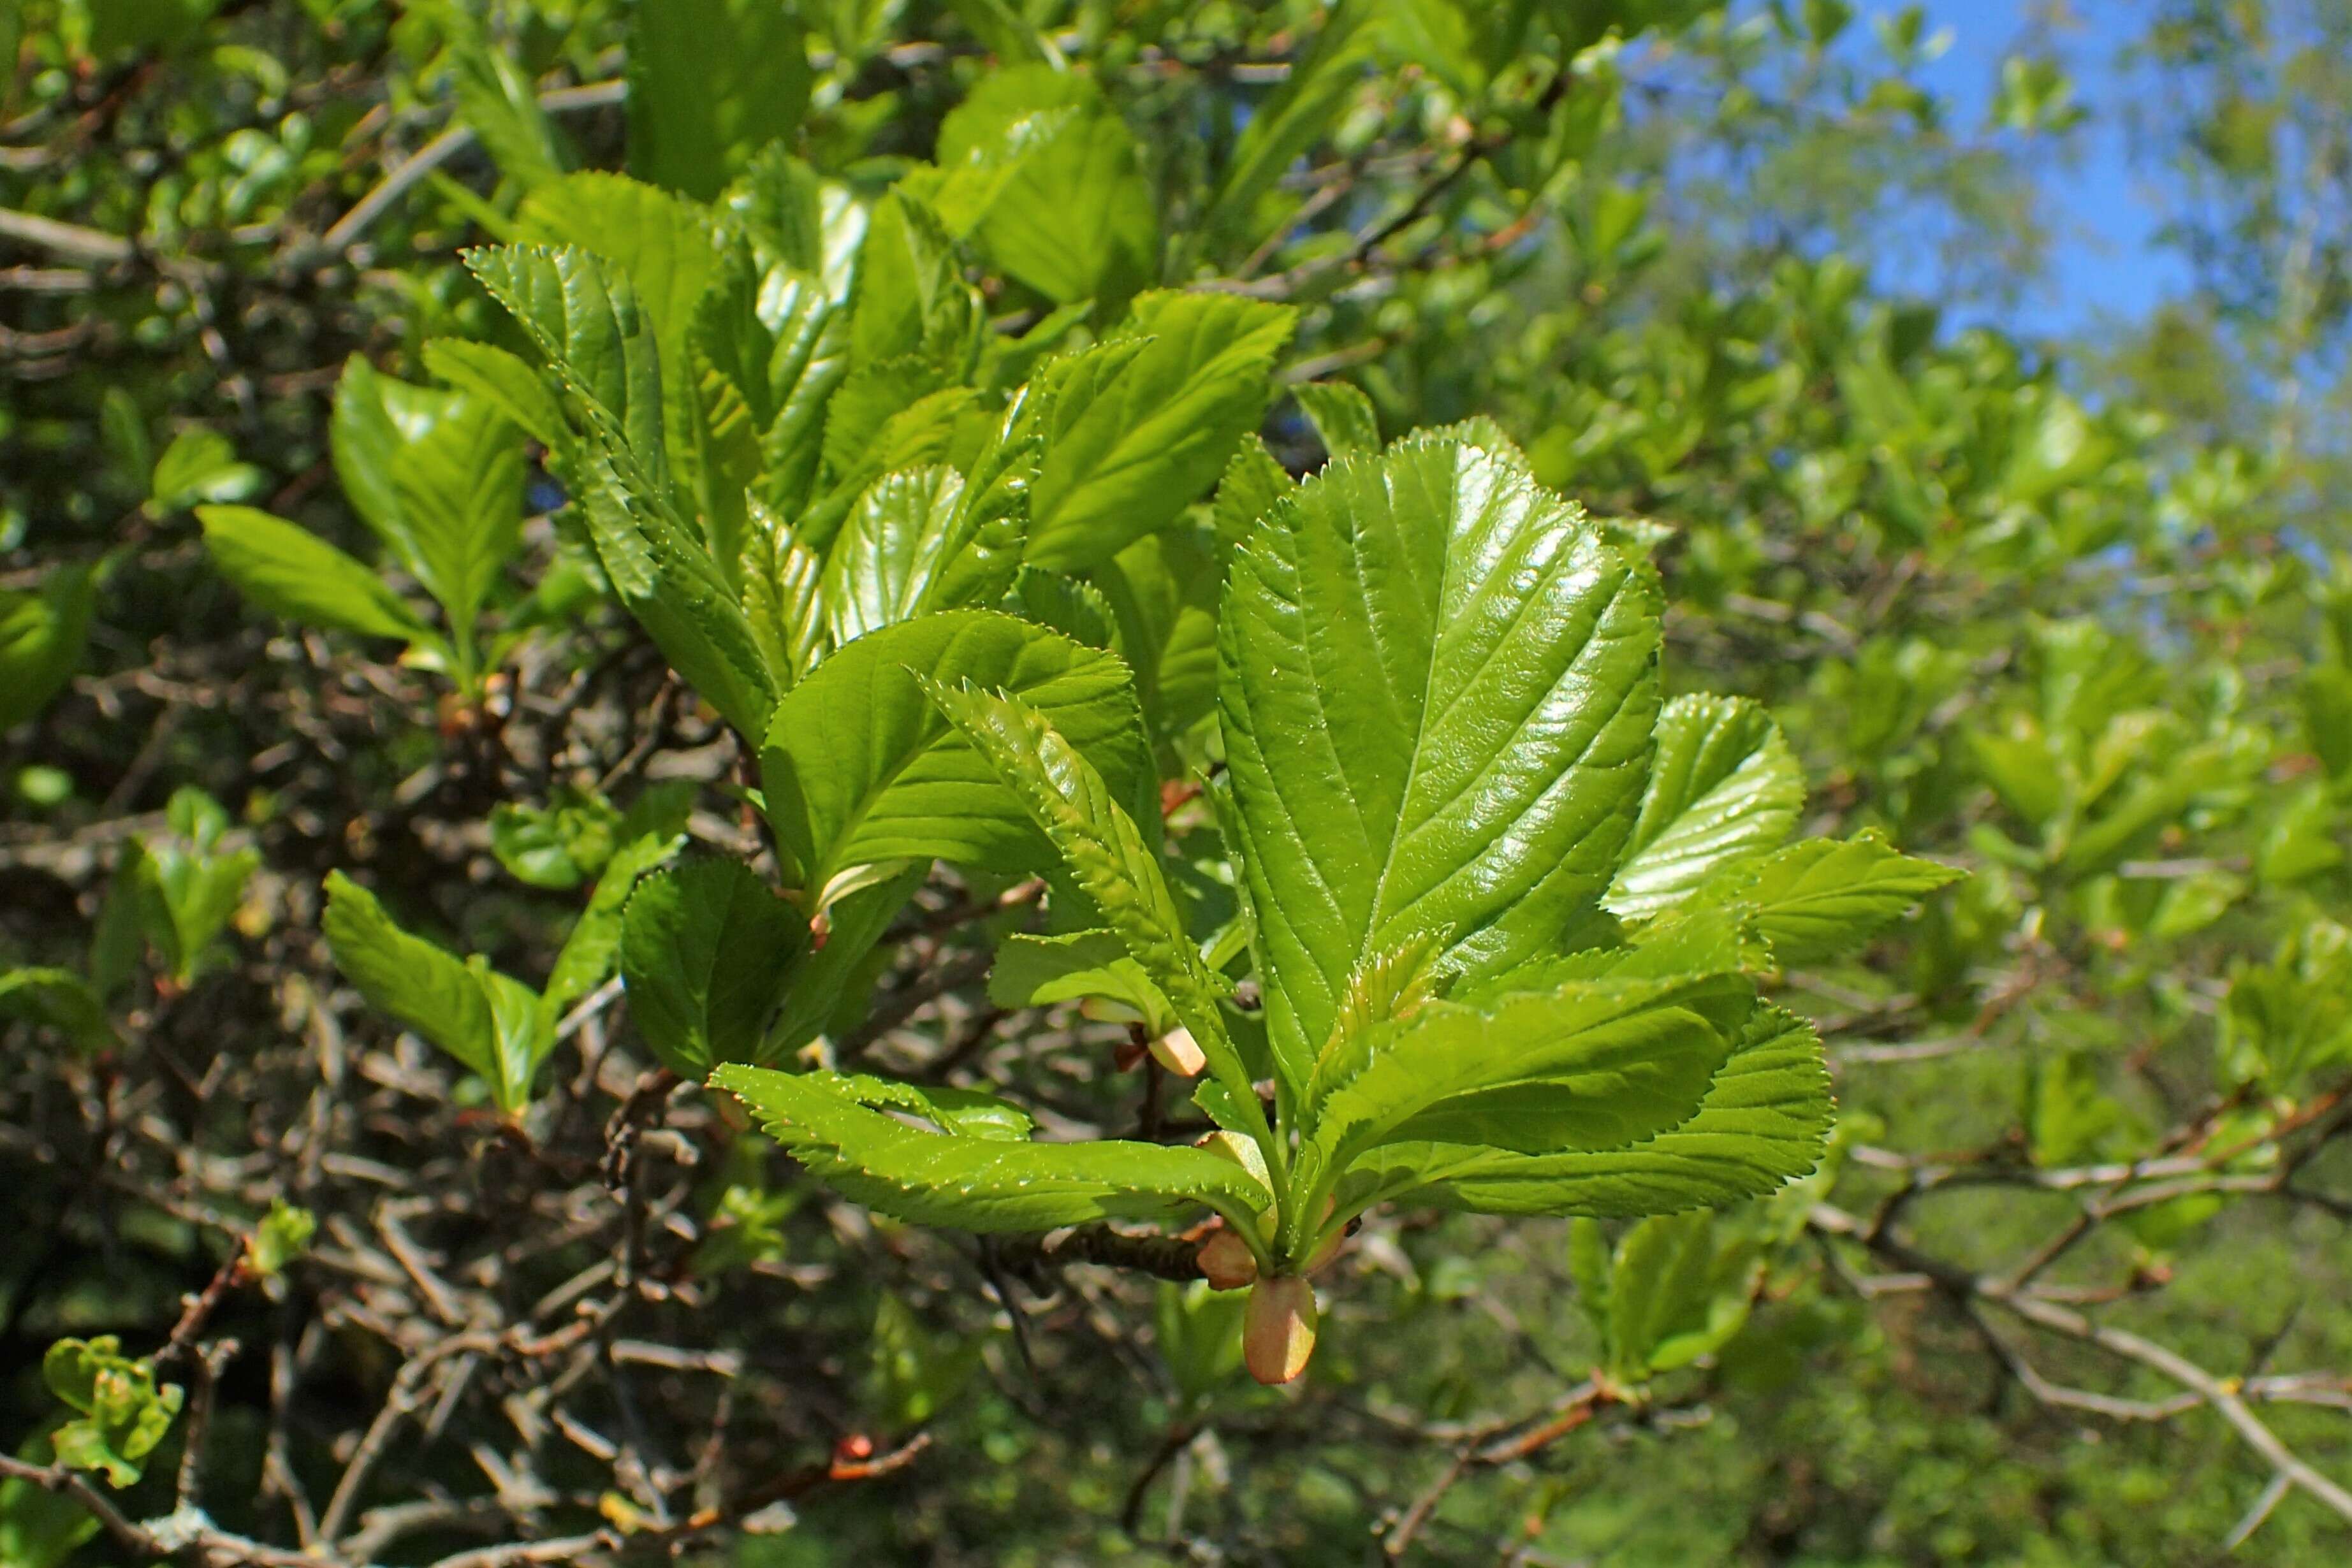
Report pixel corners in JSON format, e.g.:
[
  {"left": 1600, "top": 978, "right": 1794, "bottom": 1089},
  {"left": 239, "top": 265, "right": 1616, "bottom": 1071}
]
[{"left": 1900, "top": 0, "right": 2189, "bottom": 334}]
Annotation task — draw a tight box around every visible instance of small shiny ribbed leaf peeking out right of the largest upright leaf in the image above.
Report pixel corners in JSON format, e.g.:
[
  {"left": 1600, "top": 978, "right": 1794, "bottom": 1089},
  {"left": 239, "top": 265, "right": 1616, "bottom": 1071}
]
[{"left": 1602, "top": 696, "right": 1804, "bottom": 919}]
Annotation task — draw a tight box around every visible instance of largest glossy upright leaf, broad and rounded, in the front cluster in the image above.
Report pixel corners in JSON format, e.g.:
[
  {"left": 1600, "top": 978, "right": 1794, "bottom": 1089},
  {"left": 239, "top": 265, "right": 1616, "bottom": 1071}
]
[{"left": 1218, "top": 435, "right": 1658, "bottom": 1114}]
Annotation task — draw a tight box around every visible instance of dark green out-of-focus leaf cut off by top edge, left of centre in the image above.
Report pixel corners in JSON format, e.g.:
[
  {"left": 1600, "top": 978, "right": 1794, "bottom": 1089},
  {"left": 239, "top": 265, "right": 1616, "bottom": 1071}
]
[{"left": 628, "top": 0, "right": 809, "bottom": 202}]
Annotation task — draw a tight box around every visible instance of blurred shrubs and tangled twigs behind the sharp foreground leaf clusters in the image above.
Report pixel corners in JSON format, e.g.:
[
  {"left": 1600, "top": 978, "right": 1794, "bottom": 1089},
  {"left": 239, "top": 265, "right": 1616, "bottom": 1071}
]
[{"left": 0, "top": 0, "right": 2352, "bottom": 1568}]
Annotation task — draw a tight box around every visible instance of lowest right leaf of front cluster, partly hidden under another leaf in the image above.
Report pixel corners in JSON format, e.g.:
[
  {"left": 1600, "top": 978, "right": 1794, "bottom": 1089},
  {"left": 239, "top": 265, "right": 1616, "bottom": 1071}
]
[{"left": 1359, "top": 1008, "right": 1832, "bottom": 1217}]
